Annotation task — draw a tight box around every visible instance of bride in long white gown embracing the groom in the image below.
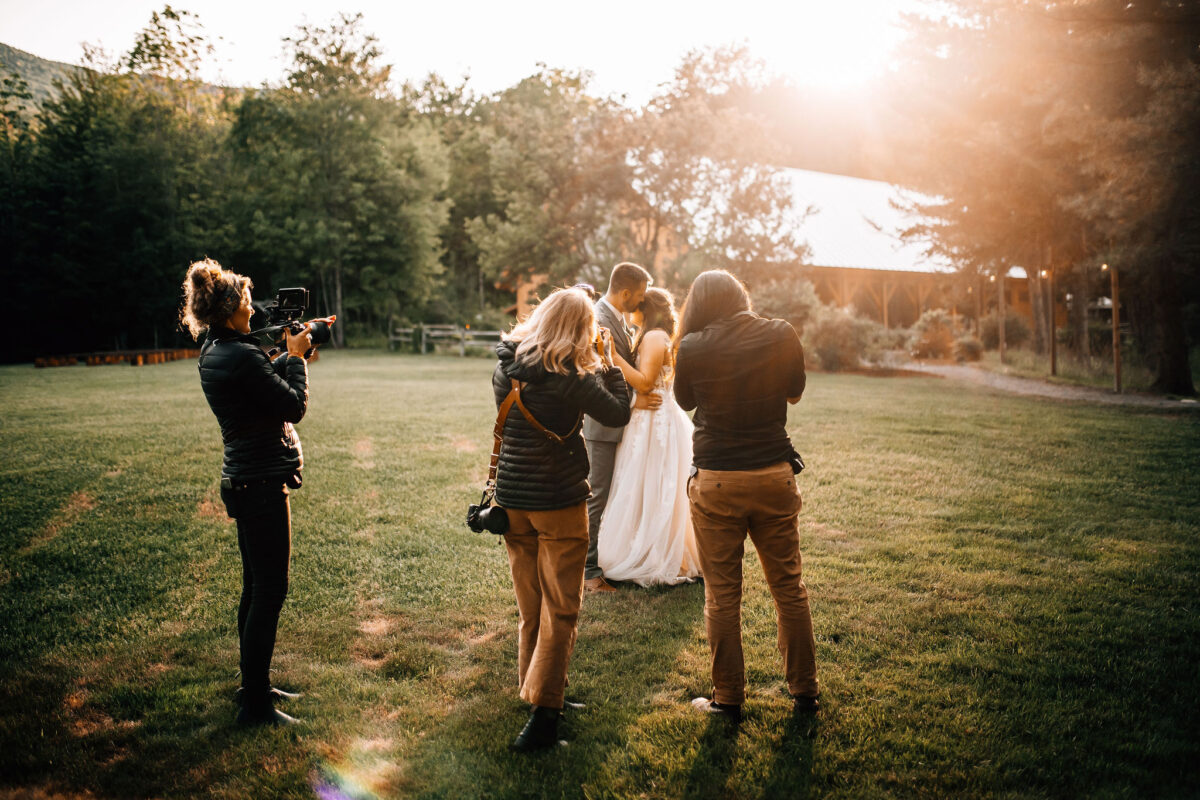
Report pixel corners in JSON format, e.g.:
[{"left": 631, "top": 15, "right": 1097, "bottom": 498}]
[{"left": 598, "top": 288, "right": 700, "bottom": 587}]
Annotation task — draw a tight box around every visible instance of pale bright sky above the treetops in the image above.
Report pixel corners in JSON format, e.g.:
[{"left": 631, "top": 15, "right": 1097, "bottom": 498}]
[{"left": 0, "top": 0, "right": 920, "bottom": 104}]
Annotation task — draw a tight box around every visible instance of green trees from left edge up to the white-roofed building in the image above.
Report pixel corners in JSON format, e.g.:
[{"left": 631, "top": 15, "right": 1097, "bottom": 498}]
[{"left": 0, "top": 6, "right": 804, "bottom": 360}]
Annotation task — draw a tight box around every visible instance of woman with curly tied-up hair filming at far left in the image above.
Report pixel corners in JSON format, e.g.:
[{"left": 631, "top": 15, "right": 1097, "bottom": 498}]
[{"left": 180, "top": 259, "right": 336, "bottom": 724}]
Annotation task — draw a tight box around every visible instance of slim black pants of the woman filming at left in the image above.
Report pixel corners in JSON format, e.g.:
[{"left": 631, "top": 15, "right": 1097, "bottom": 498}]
[{"left": 228, "top": 482, "right": 292, "bottom": 696}]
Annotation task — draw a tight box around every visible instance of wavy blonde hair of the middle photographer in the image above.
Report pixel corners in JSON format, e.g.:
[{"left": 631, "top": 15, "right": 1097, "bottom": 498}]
[{"left": 509, "top": 289, "right": 600, "bottom": 375}]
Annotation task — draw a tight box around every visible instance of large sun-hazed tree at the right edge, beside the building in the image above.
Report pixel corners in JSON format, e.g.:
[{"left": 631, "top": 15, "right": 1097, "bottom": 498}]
[{"left": 888, "top": 0, "right": 1200, "bottom": 395}]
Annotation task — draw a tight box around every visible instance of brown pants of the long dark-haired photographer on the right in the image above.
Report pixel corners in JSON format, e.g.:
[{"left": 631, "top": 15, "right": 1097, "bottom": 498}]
[{"left": 688, "top": 462, "right": 817, "bottom": 705}]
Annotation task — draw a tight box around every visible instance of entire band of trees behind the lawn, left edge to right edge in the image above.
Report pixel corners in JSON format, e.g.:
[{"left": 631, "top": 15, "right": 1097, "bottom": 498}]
[{"left": 0, "top": 0, "right": 1200, "bottom": 393}]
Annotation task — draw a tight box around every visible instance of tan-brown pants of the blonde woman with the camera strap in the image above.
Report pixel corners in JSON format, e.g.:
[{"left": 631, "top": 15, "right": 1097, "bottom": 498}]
[{"left": 504, "top": 503, "right": 588, "bottom": 709}]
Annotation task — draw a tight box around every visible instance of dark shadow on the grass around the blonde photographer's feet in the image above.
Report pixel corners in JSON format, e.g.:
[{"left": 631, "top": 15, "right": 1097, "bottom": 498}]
[{"left": 393, "top": 584, "right": 710, "bottom": 798}]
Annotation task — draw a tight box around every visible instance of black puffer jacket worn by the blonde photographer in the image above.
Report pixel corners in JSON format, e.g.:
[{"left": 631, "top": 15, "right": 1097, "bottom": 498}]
[{"left": 492, "top": 342, "right": 629, "bottom": 511}]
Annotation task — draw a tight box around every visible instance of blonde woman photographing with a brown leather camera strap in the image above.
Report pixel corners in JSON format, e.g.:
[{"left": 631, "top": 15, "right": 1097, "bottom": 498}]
[{"left": 492, "top": 289, "right": 630, "bottom": 751}]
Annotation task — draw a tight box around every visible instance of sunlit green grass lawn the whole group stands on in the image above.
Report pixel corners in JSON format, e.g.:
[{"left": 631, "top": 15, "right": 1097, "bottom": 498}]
[{"left": 0, "top": 353, "right": 1200, "bottom": 800}]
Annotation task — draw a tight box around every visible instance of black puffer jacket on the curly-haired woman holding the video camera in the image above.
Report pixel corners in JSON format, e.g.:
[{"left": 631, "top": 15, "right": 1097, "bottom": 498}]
[{"left": 199, "top": 327, "right": 308, "bottom": 483}]
